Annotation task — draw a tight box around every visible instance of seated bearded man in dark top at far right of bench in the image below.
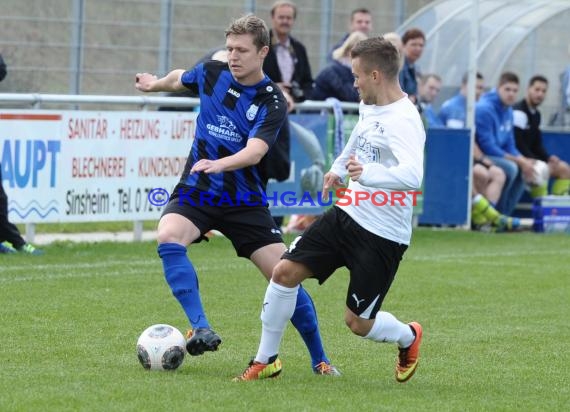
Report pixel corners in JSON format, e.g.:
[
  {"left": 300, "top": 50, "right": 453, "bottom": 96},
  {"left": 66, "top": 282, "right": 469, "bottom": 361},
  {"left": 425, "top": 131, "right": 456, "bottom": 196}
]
[{"left": 513, "top": 75, "right": 570, "bottom": 197}]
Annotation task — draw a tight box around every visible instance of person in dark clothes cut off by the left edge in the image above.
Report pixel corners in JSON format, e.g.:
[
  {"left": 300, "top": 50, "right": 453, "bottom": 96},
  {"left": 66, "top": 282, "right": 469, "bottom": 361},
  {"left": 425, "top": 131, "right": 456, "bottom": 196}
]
[{"left": 0, "top": 58, "right": 43, "bottom": 255}]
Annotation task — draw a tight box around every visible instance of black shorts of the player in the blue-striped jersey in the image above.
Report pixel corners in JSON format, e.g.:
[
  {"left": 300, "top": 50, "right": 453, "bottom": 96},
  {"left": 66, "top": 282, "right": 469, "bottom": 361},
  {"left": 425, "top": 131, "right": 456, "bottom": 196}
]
[{"left": 162, "top": 183, "right": 283, "bottom": 259}]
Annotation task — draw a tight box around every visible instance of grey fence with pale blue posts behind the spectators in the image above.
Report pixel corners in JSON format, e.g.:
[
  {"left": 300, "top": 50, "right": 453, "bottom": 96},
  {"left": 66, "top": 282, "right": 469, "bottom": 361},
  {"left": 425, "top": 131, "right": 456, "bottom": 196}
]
[{"left": 0, "top": 0, "right": 431, "bottom": 95}]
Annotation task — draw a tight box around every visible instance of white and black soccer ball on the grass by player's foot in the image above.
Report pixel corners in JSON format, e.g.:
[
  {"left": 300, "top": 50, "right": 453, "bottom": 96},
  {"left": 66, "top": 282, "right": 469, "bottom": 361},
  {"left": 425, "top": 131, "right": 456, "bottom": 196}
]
[{"left": 137, "top": 324, "right": 186, "bottom": 370}]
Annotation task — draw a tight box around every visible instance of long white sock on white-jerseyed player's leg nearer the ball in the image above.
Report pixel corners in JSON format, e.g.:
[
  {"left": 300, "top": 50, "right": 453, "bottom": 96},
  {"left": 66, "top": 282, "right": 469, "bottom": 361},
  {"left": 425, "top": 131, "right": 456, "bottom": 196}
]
[{"left": 255, "top": 280, "right": 299, "bottom": 363}]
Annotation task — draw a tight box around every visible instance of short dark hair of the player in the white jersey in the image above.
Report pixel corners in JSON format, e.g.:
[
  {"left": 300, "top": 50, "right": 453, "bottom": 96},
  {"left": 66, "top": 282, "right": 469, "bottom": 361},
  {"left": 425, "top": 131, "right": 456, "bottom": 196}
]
[{"left": 350, "top": 37, "right": 400, "bottom": 79}]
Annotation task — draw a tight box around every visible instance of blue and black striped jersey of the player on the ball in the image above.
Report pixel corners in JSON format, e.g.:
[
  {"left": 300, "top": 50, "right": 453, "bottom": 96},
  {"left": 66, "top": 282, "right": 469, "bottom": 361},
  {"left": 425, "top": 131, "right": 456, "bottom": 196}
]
[{"left": 180, "top": 61, "right": 287, "bottom": 199}]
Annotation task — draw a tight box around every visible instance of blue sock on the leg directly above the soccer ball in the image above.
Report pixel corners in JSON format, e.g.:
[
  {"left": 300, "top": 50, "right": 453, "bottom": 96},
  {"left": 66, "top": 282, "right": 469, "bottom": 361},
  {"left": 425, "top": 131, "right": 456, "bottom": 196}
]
[{"left": 158, "top": 243, "right": 210, "bottom": 329}]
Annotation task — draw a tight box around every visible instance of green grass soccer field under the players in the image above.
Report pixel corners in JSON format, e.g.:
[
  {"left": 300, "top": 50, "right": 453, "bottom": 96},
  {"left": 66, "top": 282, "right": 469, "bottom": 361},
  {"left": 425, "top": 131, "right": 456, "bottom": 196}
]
[{"left": 0, "top": 229, "right": 570, "bottom": 411}]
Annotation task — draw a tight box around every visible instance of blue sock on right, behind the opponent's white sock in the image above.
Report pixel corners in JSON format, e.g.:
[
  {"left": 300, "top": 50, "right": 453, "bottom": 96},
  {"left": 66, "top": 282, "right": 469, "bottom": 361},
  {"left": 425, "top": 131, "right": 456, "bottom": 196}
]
[{"left": 291, "top": 286, "right": 330, "bottom": 368}]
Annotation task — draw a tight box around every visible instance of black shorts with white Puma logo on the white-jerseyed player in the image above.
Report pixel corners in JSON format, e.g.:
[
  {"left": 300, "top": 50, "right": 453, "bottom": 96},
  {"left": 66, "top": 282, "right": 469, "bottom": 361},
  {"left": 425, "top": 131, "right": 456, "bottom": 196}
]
[{"left": 283, "top": 207, "right": 408, "bottom": 319}]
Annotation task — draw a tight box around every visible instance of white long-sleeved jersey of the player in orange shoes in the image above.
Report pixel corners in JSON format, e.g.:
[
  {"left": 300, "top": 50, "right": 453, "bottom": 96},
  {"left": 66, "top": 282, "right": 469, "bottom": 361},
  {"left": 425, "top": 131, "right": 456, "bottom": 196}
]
[{"left": 331, "top": 97, "right": 426, "bottom": 245}]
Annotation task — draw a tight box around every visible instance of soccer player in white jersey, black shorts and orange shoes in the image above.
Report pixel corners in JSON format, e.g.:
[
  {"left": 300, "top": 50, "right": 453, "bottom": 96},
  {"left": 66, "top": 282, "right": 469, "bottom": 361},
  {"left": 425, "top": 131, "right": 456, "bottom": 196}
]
[{"left": 235, "top": 37, "right": 425, "bottom": 382}]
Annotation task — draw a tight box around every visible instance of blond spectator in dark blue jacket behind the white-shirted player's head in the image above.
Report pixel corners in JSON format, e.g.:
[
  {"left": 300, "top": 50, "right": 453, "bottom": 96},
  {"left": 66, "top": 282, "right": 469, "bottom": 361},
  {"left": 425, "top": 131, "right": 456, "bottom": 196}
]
[{"left": 310, "top": 31, "right": 367, "bottom": 103}]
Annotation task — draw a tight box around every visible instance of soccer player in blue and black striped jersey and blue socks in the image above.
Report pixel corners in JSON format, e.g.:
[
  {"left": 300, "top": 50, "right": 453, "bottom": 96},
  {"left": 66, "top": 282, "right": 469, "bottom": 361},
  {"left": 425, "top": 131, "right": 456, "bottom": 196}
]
[{"left": 135, "top": 15, "right": 339, "bottom": 375}]
